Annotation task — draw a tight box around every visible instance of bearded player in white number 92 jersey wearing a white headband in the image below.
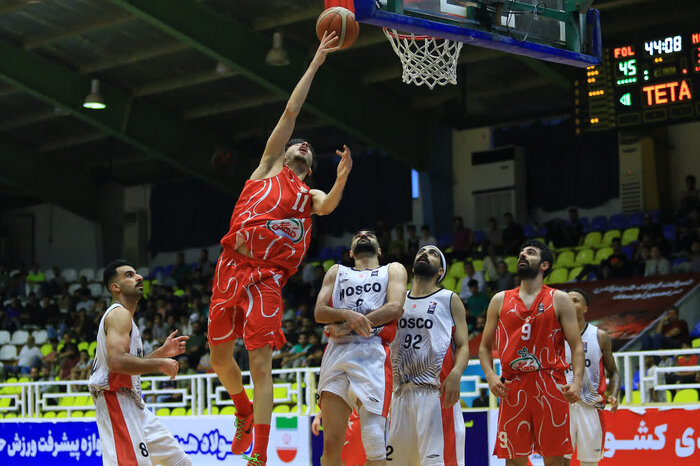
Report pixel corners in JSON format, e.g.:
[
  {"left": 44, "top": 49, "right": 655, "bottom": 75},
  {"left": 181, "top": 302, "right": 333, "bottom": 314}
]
[{"left": 387, "top": 246, "right": 469, "bottom": 466}]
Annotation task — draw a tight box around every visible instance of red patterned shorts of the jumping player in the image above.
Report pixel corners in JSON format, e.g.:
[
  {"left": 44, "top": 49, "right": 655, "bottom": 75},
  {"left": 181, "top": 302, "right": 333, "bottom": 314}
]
[{"left": 208, "top": 250, "right": 287, "bottom": 350}]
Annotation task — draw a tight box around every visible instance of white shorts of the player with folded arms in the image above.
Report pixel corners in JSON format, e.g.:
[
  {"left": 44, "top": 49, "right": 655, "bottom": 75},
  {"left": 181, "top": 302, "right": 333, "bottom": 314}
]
[{"left": 318, "top": 337, "right": 392, "bottom": 417}]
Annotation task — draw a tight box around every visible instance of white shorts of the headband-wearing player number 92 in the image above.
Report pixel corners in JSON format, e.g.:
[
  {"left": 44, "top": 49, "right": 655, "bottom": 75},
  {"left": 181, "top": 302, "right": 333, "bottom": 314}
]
[{"left": 387, "top": 387, "right": 465, "bottom": 466}]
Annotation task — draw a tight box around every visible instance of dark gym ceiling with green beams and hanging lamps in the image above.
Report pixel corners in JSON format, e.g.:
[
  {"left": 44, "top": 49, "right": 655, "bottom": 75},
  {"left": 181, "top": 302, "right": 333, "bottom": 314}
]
[{"left": 0, "top": 0, "right": 700, "bottom": 220}]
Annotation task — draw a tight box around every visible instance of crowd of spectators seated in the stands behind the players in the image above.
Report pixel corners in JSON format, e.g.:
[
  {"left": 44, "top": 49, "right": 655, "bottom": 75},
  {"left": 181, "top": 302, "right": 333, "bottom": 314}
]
[{"left": 0, "top": 198, "right": 700, "bottom": 380}]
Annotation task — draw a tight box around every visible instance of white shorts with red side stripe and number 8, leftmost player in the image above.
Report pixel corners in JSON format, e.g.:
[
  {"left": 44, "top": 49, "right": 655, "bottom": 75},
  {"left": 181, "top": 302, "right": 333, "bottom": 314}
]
[{"left": 95, "top": 391, "right": 186, "bottom": 466}]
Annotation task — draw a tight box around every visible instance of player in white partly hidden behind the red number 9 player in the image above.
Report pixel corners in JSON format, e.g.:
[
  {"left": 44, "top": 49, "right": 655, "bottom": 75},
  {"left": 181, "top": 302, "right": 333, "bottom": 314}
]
[{"left": 565, "top": 289, "right": 620, "bottom": 466}]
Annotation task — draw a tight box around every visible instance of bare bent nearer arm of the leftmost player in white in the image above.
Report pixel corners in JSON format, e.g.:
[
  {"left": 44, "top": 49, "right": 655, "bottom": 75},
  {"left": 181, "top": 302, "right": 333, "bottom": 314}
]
[{"left": 105, "top": 307, "right": 179, "bottom": 378}]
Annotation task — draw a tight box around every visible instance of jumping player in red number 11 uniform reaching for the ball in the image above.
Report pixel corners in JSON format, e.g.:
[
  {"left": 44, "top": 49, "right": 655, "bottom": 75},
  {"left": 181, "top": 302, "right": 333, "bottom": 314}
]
[{"left": 209, "top": 33, "right": 352, "bottom": 466}]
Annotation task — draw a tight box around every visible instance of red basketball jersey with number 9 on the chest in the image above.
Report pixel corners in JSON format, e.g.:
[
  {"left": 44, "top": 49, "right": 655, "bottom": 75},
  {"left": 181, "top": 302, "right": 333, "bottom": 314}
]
[{"left": 496, "top": 285, "right": 567, "bottom": 378}]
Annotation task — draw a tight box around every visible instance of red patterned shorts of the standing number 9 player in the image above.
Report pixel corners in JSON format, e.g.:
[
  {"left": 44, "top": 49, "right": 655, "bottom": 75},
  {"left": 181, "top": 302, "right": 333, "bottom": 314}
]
[{"left": 493, "top": 370, "right": 573, "bottom": 459}]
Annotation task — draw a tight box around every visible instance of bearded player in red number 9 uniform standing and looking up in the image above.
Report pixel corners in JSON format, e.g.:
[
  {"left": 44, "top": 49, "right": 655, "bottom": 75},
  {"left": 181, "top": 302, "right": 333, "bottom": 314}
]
[{"left": 479, "top": 240, "right": 584, "bottom": 466}]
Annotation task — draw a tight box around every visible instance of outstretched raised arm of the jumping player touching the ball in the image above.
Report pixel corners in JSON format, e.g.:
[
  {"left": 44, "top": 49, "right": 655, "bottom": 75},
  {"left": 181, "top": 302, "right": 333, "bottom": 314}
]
[{"left": 250, "top": 32, "right": 338, "bottom": 180}]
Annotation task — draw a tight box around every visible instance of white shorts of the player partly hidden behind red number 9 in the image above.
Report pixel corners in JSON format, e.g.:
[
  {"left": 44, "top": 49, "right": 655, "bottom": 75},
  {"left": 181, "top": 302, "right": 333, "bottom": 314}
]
[{"left": 566, "top": 401, "right": 605, "bottom": 463}]
